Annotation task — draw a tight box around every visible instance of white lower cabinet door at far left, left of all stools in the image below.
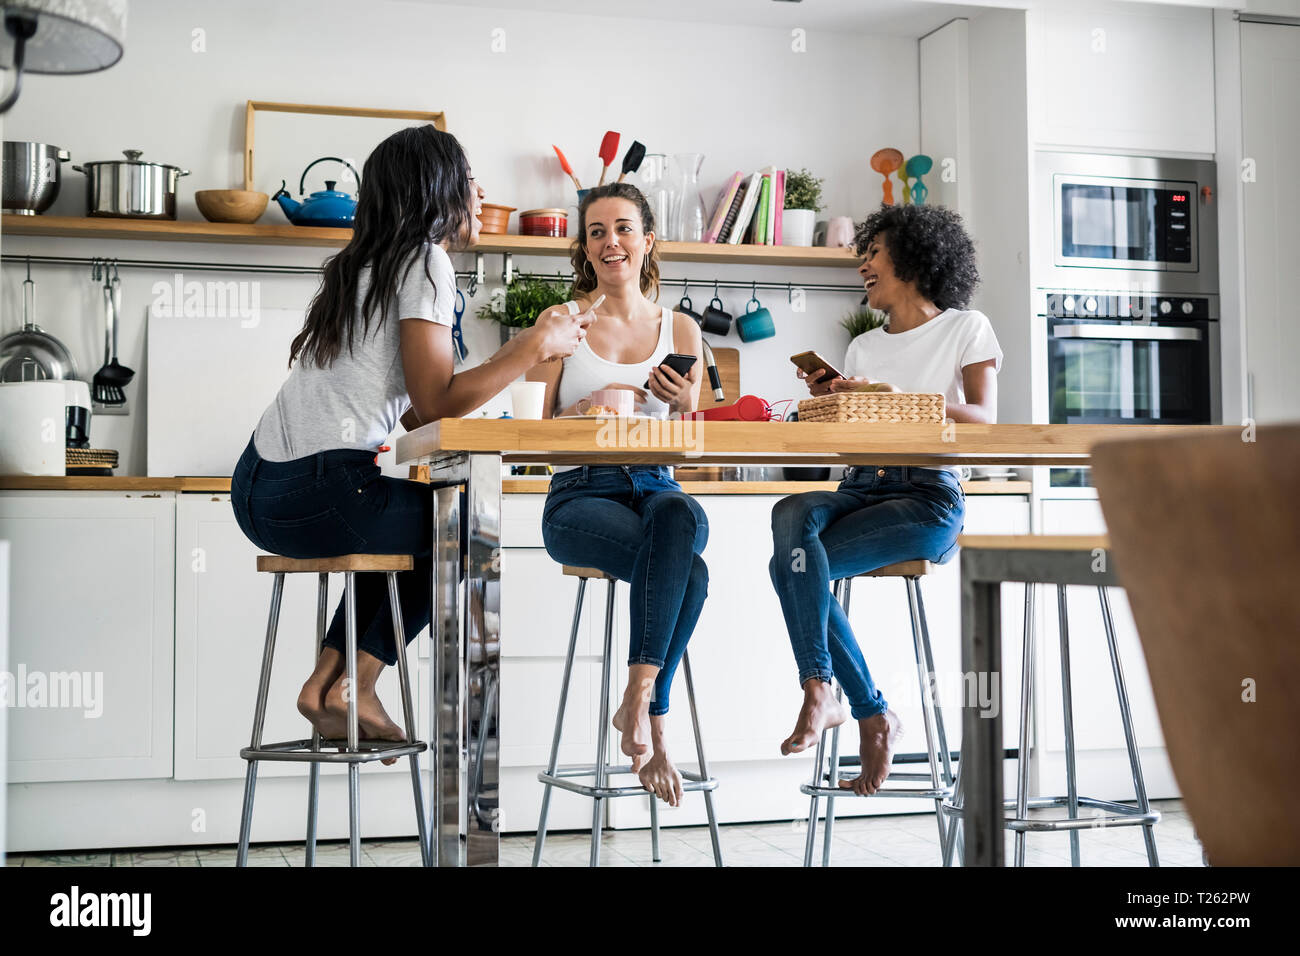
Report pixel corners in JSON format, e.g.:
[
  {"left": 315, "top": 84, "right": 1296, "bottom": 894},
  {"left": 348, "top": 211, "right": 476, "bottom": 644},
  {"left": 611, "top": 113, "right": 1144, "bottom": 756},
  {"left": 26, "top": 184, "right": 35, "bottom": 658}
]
[{"left": 0, "top": 492, "right": 176, "bottom": 783}]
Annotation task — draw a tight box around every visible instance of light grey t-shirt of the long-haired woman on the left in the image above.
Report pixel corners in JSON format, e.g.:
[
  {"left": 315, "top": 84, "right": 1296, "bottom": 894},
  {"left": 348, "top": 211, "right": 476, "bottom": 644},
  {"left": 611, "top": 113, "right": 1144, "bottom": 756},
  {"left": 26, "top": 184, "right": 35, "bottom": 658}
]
[{"left": 254, "top": 243, "right": 456, "bottom": 462}]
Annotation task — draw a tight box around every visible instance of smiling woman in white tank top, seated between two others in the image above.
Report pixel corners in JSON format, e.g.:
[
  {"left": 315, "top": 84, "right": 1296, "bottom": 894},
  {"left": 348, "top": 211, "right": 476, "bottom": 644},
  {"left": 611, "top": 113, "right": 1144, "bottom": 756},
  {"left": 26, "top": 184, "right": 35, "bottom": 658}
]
[{"left": 528, "top": 183, "right": 709, "bottom": 806}]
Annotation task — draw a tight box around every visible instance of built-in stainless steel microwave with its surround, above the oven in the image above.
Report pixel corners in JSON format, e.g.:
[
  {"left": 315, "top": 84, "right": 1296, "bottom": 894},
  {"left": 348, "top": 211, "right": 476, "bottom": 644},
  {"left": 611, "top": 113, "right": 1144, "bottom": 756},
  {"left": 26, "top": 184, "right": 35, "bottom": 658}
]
[{"left": 1035, "top": 152, "right": 1218, "bottom": 293}]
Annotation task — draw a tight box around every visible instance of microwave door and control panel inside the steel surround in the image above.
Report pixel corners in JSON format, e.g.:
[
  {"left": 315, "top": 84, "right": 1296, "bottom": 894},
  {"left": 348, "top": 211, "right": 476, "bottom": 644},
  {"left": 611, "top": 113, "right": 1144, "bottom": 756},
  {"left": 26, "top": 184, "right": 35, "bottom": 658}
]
[{"left": 1056, "top": 176, "right": 1196, "bottom": 272}]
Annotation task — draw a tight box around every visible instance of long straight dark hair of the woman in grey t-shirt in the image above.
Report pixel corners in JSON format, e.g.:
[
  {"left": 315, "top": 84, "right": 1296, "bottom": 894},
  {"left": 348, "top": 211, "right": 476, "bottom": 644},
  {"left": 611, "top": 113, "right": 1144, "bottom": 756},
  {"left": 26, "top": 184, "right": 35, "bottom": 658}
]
[{"left": 289, "top": 125, "right": 472, "bottom": 368}]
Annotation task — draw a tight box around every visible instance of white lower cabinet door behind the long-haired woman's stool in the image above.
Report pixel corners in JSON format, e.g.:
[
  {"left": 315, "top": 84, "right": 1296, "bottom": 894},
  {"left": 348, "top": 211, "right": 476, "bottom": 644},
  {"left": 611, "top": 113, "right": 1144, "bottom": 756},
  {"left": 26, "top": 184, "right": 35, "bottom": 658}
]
[{"left": 174, "top": 494, "right": 428, "bottom": 780}]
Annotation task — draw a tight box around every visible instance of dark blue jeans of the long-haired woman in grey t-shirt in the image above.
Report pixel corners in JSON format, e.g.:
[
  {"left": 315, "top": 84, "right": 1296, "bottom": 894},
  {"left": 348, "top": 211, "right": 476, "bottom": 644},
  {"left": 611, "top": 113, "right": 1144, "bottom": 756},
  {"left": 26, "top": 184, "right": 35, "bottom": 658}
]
[{"left": 230, "top": 438, "right": 433, "bottom": 665}]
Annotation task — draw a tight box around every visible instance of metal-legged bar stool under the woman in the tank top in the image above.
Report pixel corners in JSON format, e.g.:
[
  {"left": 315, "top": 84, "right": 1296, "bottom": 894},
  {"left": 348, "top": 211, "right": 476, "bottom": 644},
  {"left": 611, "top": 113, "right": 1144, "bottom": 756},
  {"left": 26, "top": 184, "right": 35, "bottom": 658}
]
[{"left": 533, "top": 566, "right": 723, "bottom": 866}]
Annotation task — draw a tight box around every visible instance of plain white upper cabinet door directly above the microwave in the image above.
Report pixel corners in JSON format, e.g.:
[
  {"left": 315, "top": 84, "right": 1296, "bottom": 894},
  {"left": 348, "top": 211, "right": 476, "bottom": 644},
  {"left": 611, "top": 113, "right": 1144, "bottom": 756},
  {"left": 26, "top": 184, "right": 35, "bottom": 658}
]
[{"left": 1026, "top": 4, "right": 1214, "bottom": 153}]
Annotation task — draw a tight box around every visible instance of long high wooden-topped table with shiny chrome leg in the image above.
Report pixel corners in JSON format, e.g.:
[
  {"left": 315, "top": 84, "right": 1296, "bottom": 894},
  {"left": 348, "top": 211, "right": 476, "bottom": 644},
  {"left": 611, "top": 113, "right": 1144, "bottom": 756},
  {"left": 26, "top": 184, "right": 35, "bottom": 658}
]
[{"left": 397, "top": 419, "right": 1235, "bottom": 866}]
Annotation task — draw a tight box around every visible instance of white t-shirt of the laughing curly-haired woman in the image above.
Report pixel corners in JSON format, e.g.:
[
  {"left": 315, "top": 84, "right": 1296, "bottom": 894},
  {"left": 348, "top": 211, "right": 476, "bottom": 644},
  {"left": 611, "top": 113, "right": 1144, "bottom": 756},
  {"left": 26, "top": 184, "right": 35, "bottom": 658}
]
[{"left": 844, "top": 308, "right": 1002, "bottom": 477}]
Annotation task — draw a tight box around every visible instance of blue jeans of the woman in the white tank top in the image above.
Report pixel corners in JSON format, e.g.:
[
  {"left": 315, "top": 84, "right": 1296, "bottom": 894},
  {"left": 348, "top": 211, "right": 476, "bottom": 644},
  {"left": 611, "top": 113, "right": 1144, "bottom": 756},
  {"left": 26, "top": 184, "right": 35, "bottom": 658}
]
[{"left": 542, "top": 466, "right": 709, "bottom": 715}]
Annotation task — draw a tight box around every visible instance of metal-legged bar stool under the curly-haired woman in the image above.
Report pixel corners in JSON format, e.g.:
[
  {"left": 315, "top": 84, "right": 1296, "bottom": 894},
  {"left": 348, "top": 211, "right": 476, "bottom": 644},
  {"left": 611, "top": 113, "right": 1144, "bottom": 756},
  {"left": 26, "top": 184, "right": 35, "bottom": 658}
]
[{"left": 800, "top": 561, "right": 957, "bottom": 866}]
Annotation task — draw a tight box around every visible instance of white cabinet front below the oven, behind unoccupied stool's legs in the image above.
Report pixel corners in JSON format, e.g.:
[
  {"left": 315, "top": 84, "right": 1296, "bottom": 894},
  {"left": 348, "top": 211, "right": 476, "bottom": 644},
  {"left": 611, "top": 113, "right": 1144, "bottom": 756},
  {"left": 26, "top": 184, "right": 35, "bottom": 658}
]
[{"left": 1035, "top": 499, "right": 1178, "bottom": 800}]
